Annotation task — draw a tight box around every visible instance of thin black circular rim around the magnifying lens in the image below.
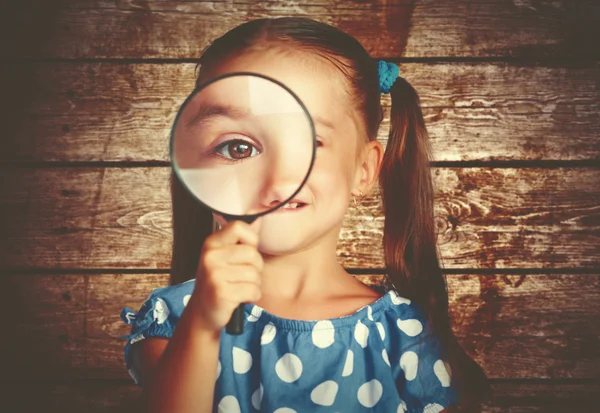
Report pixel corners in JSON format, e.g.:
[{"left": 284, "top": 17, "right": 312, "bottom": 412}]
[{"left": 169, "top": 72, "right": 317, "bottom": 221}]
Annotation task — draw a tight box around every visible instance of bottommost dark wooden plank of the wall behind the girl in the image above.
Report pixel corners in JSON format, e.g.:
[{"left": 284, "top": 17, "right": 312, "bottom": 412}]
[{"left": 0, "top": 380, "right": 600, "bottom": 413}]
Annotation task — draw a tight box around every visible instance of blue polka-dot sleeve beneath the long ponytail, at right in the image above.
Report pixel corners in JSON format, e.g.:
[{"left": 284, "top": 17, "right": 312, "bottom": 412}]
[{"left": 390, "top": 291, "right": 458, "bottom": 413}]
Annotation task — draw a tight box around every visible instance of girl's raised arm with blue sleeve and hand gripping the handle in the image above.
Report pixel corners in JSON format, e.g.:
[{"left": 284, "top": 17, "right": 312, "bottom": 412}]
[{"left": 121, "top": 221, "right": 263, "bottom": 413}]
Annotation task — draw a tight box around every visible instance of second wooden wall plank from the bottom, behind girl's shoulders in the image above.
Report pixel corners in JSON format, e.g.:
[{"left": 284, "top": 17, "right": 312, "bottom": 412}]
[{"left": 0, "top": 273, "right": 600, "bottom": 380}]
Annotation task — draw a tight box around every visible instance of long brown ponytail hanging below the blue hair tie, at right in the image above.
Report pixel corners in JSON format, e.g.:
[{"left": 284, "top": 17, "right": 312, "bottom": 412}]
[{"left": 379, "top": 77, "right": 491, "bottom": 412}]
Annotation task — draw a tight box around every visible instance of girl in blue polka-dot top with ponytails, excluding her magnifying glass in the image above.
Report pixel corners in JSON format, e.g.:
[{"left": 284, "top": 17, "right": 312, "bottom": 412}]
[{"left": 121, "top": 18, "right": 489, "bottom": 413}]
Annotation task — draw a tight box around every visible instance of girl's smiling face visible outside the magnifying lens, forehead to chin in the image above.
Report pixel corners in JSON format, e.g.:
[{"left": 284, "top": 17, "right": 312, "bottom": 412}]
[{"left": 210, "top": 51, "right": 372, "bottom": 255}]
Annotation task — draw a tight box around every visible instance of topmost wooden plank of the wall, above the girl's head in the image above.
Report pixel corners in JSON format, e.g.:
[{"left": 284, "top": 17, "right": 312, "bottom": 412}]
[{"left": 0, "top": 0, "right": 600, "bottom": 59}]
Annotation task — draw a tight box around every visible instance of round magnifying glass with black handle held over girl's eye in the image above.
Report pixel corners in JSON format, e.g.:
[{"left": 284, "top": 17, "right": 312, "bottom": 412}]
[{"left": 170, "top": 72, "right": 316, "bottom": 334}]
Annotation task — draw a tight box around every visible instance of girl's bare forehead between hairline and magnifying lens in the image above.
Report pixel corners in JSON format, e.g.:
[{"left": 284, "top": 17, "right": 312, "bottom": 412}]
[{"left": 205, "top": 51, "right": 353, "bottom": 133}]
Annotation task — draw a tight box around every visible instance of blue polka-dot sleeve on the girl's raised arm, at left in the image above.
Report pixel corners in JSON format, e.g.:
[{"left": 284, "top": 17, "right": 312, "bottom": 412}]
[{"left": 120, "top": 280, "right": 195, "bottom": 387}]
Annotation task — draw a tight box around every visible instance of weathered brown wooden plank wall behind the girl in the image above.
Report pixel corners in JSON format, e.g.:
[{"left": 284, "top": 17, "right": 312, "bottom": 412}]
[{"left": 0, "top": 0, "right": 600, "bottom": 413}]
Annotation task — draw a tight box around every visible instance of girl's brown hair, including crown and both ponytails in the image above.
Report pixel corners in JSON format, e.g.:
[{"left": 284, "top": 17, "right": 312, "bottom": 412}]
[{"left": 170, "top": 17, "right": 491, "bottom": 412}]
